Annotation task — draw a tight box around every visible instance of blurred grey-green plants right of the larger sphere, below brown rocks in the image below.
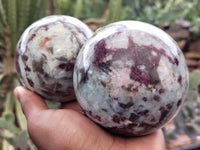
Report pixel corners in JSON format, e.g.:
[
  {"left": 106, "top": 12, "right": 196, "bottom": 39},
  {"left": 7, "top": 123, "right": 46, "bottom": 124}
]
[{"left": 166, "top": 70, "right": 200, "bottom": 140}]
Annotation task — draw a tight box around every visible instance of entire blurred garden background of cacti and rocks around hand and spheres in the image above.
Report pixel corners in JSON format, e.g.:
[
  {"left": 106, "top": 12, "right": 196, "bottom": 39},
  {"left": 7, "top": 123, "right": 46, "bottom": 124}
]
[{"left": 0, "top": 0, "right": 200, "bottom": 150}]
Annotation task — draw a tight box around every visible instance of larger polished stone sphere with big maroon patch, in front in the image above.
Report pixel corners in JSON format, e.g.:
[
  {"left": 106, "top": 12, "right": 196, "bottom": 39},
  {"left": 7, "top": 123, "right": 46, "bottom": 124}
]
[{"left": 73, "top": 21, "right": 189, "bottom": 136}]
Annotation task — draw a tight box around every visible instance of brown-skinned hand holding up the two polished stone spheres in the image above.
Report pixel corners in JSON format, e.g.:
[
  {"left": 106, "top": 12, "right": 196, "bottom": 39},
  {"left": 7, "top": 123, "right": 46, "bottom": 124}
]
[{"left": 14, "top": 87, "right": 165, "bottom": 150}]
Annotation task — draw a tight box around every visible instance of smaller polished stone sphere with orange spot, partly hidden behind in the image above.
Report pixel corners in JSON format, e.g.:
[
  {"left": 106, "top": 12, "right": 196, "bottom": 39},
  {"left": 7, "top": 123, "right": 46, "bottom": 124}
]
[{"left": 16, "top": 15, "right": 93, "bottom": 102}]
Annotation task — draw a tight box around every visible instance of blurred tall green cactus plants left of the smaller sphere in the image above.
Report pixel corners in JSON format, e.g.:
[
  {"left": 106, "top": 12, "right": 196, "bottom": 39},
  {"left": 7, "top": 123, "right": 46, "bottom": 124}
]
[{"left": 0, "top": 0, "right": 48, "bottom": 150}]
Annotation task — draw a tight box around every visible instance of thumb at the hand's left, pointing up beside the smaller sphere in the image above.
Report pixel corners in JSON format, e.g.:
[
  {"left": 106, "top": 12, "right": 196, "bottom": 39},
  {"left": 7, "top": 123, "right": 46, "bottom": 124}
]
[{"left": 14, "top": 86, "right": 48, "bottom": 119}]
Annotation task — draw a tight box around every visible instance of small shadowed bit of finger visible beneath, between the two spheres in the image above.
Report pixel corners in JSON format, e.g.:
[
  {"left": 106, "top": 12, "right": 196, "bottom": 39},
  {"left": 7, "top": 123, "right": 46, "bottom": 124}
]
[{"left": 60, "top": 101, "right": 84, "bottom": 114}]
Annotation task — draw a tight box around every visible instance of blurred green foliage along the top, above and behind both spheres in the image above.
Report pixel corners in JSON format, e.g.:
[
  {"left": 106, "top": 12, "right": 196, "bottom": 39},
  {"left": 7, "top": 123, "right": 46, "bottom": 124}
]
[{"left": 54, "top": 0, "right": 200, "bottom": 38}]
